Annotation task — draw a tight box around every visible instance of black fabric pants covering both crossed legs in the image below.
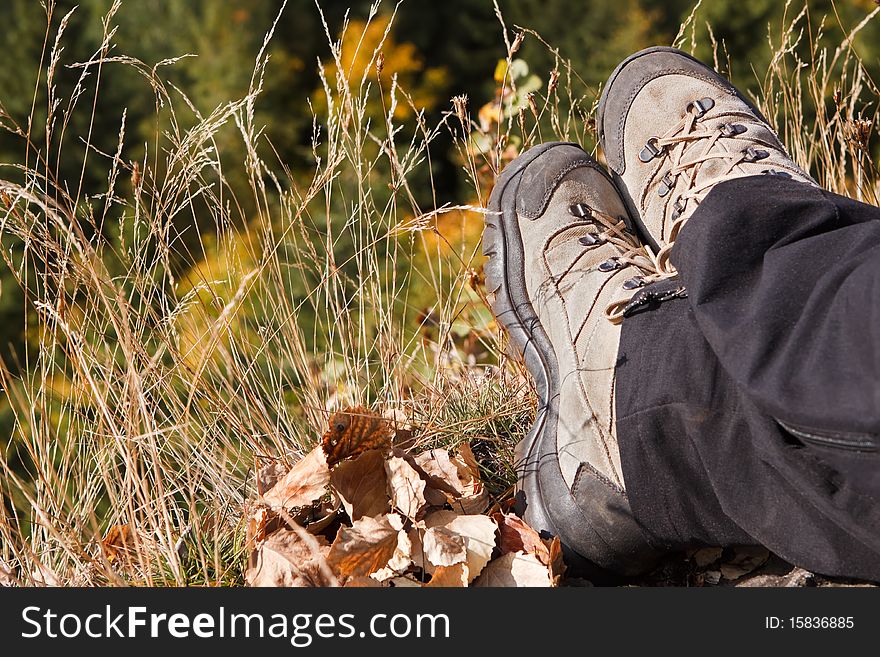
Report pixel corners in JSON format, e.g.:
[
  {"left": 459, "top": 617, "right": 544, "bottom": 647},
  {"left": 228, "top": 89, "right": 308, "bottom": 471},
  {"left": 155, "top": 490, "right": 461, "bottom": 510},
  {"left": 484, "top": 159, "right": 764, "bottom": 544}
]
[{"left": 616, "top": 176, "right": 880, "bottom": 580}]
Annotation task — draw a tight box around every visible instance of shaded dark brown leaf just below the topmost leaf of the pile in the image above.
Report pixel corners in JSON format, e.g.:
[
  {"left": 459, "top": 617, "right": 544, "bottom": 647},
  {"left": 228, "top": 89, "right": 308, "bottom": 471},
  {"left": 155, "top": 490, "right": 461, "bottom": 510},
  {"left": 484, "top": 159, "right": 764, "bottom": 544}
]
[{"left": 330, "top": 449, "right": 388, "bottom": 521}]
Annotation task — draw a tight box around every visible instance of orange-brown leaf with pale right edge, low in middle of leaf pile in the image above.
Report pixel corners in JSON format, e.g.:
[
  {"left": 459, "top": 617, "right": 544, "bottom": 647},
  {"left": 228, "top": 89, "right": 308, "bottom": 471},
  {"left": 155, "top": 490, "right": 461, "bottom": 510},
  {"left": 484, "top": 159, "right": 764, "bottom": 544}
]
[{"left": 327, "top": 513, "right": 409, "bottom": 579}]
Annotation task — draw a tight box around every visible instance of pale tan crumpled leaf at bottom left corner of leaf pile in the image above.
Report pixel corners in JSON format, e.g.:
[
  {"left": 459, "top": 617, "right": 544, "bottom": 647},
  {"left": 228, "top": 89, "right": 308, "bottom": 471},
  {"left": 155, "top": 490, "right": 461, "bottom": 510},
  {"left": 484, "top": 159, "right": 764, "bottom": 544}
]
[{"left": 245, "top": 529, "right": 333, "bottom": 587}]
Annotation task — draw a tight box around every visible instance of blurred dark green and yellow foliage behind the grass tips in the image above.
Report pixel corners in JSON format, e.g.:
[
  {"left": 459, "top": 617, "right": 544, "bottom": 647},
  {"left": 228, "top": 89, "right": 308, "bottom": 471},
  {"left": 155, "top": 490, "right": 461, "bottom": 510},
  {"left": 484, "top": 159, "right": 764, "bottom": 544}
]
[{"left": 0, "top": 0, "right": 880, "bottom": 428}]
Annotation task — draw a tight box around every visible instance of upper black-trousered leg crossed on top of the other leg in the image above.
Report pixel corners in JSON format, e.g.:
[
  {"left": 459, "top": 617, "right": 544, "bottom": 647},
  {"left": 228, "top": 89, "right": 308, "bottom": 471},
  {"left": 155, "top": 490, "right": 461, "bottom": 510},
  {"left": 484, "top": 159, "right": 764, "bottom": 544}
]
[{"left": 672, "top": 176, "right": 880, "bottom": 440}]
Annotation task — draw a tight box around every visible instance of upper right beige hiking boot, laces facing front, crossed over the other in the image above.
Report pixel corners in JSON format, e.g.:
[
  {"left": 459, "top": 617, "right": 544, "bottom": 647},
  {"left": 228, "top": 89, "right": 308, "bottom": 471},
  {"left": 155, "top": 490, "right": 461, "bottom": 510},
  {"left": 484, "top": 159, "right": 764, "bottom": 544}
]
[{"left": 596, "top": 47, "right": 816, "bottom": 255}]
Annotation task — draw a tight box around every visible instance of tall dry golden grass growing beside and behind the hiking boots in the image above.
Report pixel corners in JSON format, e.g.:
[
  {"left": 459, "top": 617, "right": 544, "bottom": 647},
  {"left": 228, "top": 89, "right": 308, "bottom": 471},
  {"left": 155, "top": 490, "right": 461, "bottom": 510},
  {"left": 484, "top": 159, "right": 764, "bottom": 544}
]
[{"left": 0, "top": 2, "right": 878, "bottom": 586}]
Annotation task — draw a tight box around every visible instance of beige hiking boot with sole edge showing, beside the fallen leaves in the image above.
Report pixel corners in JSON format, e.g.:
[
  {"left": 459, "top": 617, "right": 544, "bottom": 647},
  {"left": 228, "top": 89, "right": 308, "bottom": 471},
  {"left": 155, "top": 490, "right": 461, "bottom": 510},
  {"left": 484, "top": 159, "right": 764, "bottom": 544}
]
[{"left": 483, "top": 143, "right": 657, "bottom": 575}]
